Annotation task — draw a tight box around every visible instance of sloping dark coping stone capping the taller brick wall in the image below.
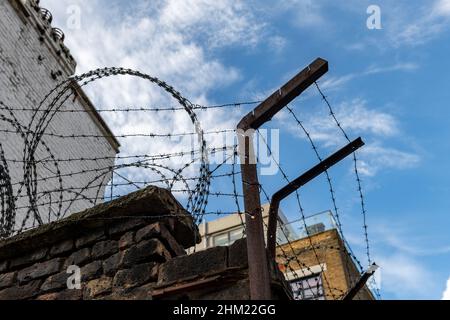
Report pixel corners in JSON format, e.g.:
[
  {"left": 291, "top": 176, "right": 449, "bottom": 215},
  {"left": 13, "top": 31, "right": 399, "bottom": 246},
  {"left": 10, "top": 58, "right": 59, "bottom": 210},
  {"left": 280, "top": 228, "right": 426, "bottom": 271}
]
[{"left": 0, "top": 186, "right": 201, "bottom": 260}]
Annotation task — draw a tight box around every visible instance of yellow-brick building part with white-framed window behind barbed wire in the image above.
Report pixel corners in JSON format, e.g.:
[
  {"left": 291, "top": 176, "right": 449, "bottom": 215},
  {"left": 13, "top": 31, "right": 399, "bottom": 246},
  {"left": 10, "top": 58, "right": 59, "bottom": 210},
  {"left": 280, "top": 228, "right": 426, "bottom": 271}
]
[{"left": 276, "top": 229, "right": 374, "bottom": 300}]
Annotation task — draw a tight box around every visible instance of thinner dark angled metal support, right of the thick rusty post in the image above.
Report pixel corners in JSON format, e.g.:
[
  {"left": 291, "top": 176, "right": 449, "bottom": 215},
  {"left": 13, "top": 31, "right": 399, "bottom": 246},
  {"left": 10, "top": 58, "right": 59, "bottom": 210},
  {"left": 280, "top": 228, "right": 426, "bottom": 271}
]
[{"left": 267, "top": 138, "right": 364, "bottom": 261}]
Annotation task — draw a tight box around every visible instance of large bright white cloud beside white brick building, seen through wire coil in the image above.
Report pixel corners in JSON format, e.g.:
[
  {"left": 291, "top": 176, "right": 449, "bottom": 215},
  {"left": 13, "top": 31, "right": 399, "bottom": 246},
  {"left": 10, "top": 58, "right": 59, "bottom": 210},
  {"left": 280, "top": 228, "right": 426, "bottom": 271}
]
[{"left": 37, "top": 0, "right": 268, "bottom": 199}]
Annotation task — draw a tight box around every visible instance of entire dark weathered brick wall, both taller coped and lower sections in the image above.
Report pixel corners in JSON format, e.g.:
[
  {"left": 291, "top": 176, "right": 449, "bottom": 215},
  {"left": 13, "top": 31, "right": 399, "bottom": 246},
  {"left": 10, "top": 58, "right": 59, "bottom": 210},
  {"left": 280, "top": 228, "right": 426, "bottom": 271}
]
[{"left": 0, "top": 187, "right": 289, "bottom": 300}]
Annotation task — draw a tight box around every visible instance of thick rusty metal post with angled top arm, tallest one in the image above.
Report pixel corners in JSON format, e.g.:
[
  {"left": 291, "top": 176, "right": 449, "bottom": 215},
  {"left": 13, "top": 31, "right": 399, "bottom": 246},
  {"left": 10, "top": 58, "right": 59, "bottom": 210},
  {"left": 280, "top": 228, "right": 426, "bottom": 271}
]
[{"left": 237, "top": 58, "right": 328, "bottom": 300}]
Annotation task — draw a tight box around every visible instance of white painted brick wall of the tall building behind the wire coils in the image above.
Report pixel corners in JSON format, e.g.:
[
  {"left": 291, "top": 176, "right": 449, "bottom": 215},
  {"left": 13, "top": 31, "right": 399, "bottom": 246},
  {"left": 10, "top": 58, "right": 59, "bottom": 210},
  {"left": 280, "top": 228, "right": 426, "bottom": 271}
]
[{"left": 0, "top": 0, "right": 116, "bottom": 235}]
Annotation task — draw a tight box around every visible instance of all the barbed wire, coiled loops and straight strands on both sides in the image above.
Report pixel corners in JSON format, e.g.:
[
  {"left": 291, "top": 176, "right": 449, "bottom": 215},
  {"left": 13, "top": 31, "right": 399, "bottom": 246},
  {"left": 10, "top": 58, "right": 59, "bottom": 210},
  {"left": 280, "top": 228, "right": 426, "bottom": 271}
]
[{"left": 0, "top": 68, "right": 379, "bottom": 298}]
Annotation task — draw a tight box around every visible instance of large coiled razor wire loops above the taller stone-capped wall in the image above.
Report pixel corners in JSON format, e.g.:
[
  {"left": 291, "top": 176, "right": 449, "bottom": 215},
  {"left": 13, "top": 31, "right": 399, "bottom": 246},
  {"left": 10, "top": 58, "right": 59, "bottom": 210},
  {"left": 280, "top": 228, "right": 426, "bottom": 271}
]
[{"left": 0, "top": 67, "right": 210, "bottom": 237}]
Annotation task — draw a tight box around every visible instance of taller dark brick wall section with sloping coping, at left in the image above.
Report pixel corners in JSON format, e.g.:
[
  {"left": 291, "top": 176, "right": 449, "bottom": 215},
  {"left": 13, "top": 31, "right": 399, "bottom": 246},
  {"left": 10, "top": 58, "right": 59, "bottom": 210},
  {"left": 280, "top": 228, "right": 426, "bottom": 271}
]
[{"left": 0, "top": 187, "right": 197, "bottom": 300}]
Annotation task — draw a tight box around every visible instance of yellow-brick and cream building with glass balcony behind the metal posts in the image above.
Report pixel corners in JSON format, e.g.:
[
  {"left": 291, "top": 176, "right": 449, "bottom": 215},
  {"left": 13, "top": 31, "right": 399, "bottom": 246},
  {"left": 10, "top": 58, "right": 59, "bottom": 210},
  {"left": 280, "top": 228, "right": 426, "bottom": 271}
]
[{"left": 189, "top": 209, "right": 374, "bottom": 300}]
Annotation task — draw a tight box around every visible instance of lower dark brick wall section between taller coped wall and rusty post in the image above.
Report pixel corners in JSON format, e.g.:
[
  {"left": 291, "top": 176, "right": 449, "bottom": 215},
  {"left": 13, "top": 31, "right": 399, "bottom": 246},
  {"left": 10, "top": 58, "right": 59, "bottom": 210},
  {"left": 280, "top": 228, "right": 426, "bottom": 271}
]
[{"left": 153, "top": 239, "right": 292, "bottom": 300}]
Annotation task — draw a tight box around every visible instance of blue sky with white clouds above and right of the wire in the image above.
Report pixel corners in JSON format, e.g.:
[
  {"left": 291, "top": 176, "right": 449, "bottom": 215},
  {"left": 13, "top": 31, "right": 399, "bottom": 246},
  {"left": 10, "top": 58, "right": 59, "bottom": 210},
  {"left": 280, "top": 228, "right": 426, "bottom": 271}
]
[{"left": 41, "top": 0, "right": 450, "bottom": 299}]
